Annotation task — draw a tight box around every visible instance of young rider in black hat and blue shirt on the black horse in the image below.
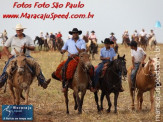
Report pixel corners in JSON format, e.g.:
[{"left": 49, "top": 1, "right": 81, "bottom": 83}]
[{"left": 94, "top": 38, "right": 124, "bottom": 92}]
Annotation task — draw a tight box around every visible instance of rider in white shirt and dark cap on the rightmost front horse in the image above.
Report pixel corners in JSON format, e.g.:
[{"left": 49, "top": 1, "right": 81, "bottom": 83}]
[{"left": 130, "top": 41, "right": 146, "bottom": 89}]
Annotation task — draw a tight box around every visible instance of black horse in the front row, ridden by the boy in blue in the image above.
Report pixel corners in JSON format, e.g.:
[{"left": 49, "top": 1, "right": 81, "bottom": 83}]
[{"left": 94, "top": 55, "right": 127, "bottom": 113}]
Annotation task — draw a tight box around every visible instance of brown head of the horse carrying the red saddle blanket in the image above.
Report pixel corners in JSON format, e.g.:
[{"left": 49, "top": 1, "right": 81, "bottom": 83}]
[{"left": 79, "top": 52, "right": 92, "bottom": 69}]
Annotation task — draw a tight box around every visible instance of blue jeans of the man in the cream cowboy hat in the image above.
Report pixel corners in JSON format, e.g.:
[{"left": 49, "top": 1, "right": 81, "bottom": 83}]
[{"left": 0, "top": 56, "right": 46, "bottom": 85}]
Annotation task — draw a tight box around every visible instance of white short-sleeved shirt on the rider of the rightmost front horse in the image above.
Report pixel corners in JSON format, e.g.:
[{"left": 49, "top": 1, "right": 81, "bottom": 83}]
[{"left": 131, "top": 47, "right": 146, "bottom": 63}]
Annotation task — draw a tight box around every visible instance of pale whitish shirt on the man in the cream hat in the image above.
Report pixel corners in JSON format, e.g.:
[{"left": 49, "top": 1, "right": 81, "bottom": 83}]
[{"left": 5, "top": 35, "right": 35, "bottom": 56}]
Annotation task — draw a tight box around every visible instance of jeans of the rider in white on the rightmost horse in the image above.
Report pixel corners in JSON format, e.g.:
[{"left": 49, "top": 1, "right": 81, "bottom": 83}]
[{"left": 131, "top": 63, "right": 140, "bottom": 86}]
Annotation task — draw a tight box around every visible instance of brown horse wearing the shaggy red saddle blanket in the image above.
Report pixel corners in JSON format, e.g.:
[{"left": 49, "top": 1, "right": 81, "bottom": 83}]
[{"left": 52, "top": 52, "right": 92, "bottom": 114}]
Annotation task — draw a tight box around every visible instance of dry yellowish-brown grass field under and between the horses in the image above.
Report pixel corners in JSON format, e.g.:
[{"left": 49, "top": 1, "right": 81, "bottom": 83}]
[{"left": 0, "top": 45, "right": 163, "bottom": 122}]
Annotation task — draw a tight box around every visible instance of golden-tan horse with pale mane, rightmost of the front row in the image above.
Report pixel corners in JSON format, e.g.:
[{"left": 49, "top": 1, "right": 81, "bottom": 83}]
[{"left": 128, "top": 58, "right": 156, "bottom": 111}]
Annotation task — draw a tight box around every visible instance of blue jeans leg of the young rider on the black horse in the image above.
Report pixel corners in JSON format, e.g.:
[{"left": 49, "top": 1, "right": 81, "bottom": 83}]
[{"left": 94, "top": 62, "right": 104, "bottom": 86}]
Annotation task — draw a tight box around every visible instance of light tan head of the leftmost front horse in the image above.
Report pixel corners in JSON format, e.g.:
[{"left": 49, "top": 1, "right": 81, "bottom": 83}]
[{"left": 14, "top": 49, "right": 26, "bottom": 75}]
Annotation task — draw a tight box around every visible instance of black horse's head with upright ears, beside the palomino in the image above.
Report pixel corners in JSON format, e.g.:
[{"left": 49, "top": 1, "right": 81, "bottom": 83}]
[{"left": 115, "top": 55, "right": 127, "bottom": 76}]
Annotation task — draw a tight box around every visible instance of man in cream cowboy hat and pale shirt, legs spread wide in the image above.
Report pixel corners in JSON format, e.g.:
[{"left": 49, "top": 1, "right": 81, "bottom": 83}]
[{"left": 0, "top": 24, "right": 51, "bottom": 89}]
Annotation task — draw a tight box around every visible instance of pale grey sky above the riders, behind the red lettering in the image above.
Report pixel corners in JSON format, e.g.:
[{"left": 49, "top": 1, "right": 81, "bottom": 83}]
[{"left": 0, "top": 0, "right": 163, "bottom": 43}]
